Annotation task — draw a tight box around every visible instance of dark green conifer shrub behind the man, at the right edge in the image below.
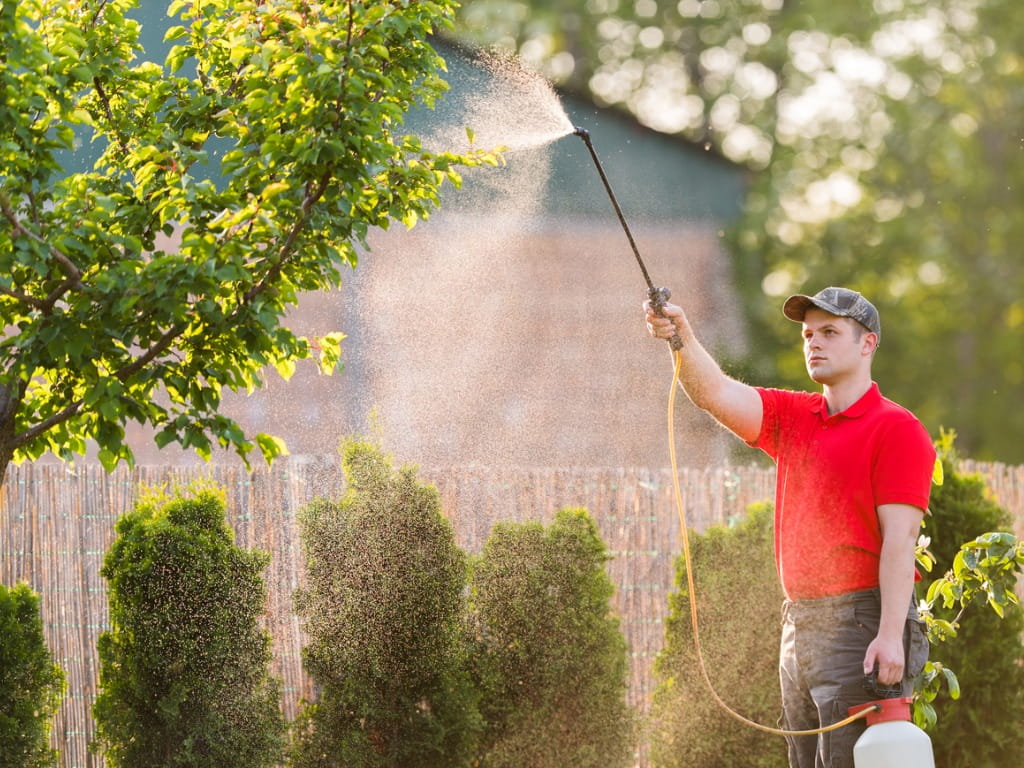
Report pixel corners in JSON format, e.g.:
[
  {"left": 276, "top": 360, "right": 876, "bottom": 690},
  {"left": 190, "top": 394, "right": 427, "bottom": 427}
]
[{"left": 925, "top": 445, "right": 1024, "bottom": 768}]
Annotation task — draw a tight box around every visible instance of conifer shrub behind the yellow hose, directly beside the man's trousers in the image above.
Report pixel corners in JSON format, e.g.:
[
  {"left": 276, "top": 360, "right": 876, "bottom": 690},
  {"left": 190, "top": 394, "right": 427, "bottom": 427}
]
[{"left": 650, "top": 504, "right": 787, "bottom": 768}]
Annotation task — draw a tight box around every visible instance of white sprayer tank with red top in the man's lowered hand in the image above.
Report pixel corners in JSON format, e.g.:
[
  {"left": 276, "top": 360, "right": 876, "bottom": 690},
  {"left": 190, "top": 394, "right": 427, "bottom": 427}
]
[{"left": 850, "top": 696, "right": 935, "bottom": 768}]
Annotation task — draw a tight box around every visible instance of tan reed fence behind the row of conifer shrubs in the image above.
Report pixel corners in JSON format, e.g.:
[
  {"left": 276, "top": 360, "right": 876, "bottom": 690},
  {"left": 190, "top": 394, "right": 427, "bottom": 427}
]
[{"left": 0, "top": 459, "right": 1024, "bottom": 768}]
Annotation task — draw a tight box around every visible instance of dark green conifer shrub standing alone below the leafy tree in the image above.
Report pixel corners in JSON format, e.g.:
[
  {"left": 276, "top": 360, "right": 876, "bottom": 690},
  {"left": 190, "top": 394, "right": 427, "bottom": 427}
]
[{"left": 93, "top": 487, "right": 286, "bottom": 768}]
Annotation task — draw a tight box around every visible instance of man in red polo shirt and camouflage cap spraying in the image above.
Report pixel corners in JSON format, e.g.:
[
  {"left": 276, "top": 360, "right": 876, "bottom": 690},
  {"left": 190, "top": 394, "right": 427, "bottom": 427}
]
[{"left": 644, "top": 288, "right": 935, "bottom": 768}]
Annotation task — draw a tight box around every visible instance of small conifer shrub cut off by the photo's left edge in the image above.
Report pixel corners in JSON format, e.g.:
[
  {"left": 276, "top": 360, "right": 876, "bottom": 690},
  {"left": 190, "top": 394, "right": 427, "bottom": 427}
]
[{"left": 0, "top": 584, "right": 65, "bottom": 768}]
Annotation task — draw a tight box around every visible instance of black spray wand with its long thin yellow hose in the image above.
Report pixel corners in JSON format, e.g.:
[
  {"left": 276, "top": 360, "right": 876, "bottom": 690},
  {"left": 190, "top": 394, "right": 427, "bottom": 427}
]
[{"left": 572, "top": 127, "right": 881, "bottom": 736}]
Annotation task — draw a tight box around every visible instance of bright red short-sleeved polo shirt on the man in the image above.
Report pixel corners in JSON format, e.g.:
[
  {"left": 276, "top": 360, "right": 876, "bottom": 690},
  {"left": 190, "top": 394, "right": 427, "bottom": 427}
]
[{"left": 751, "top": 384, "right": 935, "bottom": 600}]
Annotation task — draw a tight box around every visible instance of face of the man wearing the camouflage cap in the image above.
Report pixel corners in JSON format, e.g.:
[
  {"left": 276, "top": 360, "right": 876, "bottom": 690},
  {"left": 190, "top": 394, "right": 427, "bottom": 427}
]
[{"left": 804, "top": 307, "right": 878, "bottom": 385}]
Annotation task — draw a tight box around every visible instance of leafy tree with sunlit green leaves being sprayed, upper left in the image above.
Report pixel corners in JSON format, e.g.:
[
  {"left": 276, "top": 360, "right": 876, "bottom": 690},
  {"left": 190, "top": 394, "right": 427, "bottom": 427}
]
[{"left": 0, "top": 0, "right": 494, "bottom": 479}]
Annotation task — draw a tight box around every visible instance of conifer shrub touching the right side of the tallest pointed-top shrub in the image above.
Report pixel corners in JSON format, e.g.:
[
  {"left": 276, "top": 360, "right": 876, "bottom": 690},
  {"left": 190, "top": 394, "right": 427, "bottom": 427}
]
[{"left": 471, "top": 509, "right": 635, "bottom": 768}]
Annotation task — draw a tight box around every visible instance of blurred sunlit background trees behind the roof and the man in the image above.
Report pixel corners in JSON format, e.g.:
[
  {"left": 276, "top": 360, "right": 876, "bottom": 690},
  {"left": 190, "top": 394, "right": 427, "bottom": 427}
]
[{"left": 456, "top": 0, "right": 1024, "bottom": 463}]
